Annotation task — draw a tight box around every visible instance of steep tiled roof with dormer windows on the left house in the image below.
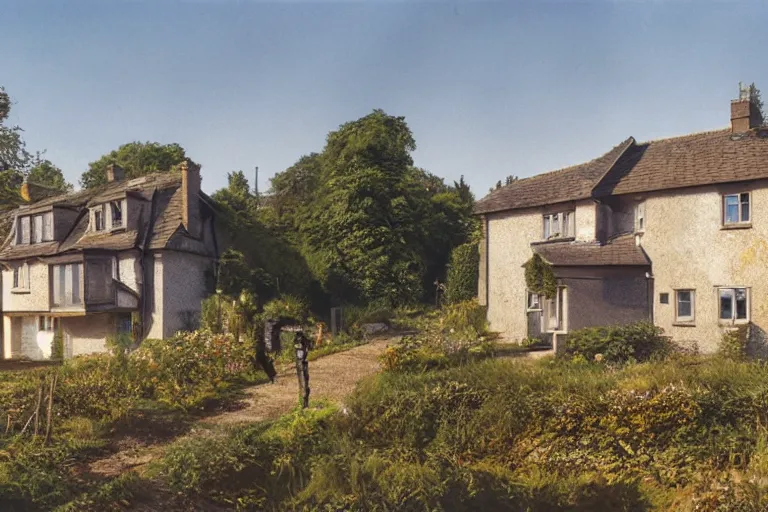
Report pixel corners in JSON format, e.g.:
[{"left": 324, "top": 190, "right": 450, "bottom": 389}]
[{"left": 0, "top": 173, "right": 210, "bottom": 260}]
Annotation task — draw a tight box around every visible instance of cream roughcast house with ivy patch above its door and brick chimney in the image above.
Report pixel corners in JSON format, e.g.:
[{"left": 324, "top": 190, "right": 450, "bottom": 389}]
[{"left": 475, "top": 86, "right": 768, "bottom": 352}]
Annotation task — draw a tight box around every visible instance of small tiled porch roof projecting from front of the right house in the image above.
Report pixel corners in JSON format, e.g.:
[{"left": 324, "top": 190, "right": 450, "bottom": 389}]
[{"left": 532, "top": 234, "right": 651, "bottom": 267}]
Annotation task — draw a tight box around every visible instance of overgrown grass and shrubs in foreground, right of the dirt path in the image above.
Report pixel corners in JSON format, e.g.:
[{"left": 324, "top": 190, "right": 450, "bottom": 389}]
[{"left": 140, "top": 356, "right": 768, "bottom": 512}]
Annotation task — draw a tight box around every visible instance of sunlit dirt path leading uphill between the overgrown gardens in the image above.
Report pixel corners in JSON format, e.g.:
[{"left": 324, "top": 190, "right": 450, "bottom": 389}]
[{"left": 88, "top": 336, "right": 398, "bottom": 477}]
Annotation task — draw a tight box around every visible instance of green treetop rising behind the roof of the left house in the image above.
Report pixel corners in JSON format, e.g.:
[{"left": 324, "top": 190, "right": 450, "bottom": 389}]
[{"left": 80, "top": 142, "right": 187, "bottom": 188}]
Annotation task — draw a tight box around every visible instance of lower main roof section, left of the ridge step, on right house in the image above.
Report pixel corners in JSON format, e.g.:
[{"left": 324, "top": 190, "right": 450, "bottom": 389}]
[{"left": 475, "top": 137, "right": 635, "bottom": 214}]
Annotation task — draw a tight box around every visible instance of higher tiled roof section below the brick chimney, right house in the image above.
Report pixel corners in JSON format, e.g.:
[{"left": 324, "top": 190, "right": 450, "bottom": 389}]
[{"left": 595, "top": 129, "right": 768, "bottom": 196}]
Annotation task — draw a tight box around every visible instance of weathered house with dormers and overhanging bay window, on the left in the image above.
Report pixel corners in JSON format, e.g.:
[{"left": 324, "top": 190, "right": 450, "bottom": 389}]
[{"left": 0, "top": 161, "right": 219, "bottom": 359}]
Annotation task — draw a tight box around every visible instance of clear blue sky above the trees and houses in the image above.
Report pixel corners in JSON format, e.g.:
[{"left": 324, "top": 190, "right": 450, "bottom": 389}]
[{"left": 0, "top": 0, "right": 768, "bottom": 196}]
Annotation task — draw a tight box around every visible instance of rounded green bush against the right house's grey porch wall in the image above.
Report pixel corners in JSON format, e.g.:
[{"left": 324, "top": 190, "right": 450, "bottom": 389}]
[{"left": 566, "top": 322, "right": 672, "bottom": 364}]
